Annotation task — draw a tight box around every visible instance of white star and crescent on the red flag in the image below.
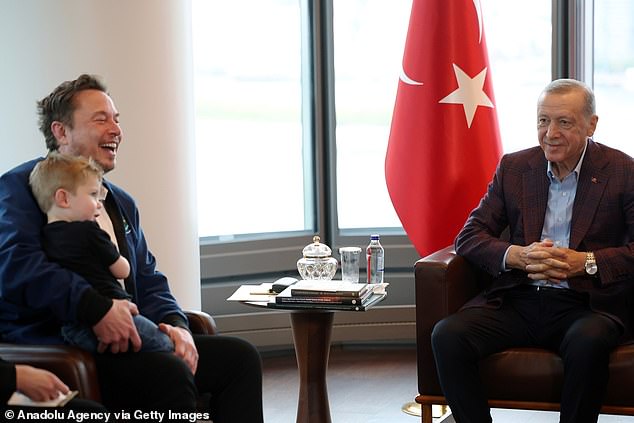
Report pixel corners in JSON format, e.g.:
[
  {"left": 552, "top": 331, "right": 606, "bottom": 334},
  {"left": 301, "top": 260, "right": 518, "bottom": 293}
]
[{"left": 399, "top": 0, "right": 495, "bottom": 128}]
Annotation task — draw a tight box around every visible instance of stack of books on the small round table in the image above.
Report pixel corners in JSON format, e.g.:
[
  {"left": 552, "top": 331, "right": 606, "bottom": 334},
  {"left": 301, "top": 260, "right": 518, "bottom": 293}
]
[{"left": 272, "top": 280, "right": 385, "bottom": 311}]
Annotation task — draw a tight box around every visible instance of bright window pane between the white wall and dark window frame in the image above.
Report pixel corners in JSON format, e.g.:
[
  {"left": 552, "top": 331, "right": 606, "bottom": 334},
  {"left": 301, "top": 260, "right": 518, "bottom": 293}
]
[{"left": 192, "top": 0, "right": 314, "bottom": 240}]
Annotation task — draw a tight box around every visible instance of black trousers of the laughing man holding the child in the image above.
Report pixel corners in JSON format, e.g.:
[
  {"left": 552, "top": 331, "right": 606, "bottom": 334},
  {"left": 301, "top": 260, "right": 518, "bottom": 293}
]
[{"left": 95, "top": 335, "right": 263, "bottom": 423}]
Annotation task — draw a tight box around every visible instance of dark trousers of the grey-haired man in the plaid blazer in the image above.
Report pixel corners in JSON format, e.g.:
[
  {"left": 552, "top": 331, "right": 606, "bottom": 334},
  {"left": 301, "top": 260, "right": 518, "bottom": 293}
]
[{"left": 432, "top": 285, "right": 621, "bottom": 423}]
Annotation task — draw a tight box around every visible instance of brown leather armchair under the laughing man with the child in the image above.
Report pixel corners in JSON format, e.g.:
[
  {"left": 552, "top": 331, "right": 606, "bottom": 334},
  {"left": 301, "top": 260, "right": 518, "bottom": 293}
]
[{"left": 0, "top": 311, "right": 216, "bottom": 401}]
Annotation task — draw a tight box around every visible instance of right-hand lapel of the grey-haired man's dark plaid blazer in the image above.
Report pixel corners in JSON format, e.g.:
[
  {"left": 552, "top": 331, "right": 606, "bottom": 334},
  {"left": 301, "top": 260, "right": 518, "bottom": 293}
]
[{"left": 569, "top": 141, "right": 609, "bottom": 250}]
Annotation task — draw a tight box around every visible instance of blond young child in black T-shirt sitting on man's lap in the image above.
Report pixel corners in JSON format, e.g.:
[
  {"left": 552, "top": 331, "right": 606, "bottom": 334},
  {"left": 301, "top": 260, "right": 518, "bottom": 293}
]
[{"left": 29, "top": 152, "right": 174, "bottom": 352}]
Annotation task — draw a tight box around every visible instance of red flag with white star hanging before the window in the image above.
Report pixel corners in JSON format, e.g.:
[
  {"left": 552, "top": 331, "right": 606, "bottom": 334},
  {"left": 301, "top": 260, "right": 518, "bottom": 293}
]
[{"left": 385, "top": 0, "right": 502, "bottom": 256}]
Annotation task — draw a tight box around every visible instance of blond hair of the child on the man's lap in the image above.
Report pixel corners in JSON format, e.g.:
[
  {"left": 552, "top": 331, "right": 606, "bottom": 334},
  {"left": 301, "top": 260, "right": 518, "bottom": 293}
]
[{"left": 29, "top": 151, "right": 103, "bottom": 213}]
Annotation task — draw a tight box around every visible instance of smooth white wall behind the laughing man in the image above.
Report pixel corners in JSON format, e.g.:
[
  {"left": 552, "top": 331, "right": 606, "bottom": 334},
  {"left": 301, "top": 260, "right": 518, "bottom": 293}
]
[{"left": 0, "top": 0, "right": 200, "bottom": 309}]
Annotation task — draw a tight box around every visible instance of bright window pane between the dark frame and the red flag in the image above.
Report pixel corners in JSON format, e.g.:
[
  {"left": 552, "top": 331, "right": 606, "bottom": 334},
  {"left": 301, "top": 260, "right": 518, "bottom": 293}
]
[{"left": 333, "top": 0, "right": 412, "bottom": 229}]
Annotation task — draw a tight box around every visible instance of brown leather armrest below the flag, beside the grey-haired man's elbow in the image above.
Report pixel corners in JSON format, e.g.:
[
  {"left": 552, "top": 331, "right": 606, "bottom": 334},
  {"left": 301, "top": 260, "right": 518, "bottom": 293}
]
[{"left": 415, "top": 246, "right": 484, "bottom": 396}]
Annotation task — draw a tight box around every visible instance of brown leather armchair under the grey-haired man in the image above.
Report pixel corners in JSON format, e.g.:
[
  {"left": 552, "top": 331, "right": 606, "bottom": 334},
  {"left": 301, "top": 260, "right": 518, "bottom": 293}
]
[{"left": 415, "top": 247, "right": 634, "bottom": 423}]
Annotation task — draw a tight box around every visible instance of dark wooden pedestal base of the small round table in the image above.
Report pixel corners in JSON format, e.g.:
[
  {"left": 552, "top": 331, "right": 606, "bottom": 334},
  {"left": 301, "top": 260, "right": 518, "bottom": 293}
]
[{"left": 291, "top": 310, "right": 334, "bottom": 423}]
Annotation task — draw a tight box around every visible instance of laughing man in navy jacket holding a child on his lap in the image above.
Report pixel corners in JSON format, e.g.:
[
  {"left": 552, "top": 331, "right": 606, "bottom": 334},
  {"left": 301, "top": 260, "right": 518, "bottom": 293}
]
[{"left": 0, "top": 75, "right": 263, "bottom": 423}]
